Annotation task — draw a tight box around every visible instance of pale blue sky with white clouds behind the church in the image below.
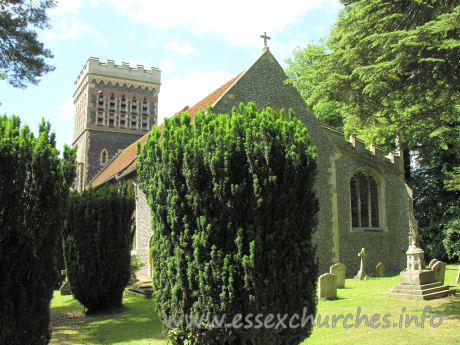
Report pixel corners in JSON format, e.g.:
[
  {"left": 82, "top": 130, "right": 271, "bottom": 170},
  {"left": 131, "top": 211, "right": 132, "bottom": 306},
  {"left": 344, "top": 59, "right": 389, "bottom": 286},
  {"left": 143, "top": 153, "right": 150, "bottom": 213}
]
[{"left": 0, "top": 0, "right": 340, "bottom": 149}]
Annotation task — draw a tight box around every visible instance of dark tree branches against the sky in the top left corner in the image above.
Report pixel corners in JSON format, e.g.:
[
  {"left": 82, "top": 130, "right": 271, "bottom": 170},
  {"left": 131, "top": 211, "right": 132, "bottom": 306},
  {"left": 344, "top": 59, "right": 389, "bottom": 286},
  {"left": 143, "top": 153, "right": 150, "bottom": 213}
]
[{"left": 0, "top": 0, "right": 56, "bottom": 88}]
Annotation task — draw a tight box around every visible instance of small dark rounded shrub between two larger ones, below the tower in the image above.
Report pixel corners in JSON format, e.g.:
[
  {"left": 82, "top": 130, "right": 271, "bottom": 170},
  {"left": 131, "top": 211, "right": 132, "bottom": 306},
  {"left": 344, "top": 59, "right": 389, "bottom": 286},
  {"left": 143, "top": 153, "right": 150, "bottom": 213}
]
[{"left": 63, "top": 187, "right": 134, "bottom": 313}]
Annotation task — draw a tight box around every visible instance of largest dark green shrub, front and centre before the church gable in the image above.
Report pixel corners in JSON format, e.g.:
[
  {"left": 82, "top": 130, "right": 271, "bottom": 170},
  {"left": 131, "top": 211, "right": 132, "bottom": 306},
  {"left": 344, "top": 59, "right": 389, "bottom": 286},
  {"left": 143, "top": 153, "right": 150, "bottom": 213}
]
[{"left": 138, "top": 103, "right": 318, "bottom": 345}]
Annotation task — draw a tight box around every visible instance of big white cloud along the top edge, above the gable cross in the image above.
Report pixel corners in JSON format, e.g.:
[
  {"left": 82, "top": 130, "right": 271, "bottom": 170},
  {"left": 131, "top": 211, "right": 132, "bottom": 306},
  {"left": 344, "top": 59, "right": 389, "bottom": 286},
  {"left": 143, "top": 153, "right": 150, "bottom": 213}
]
[{"left": 106, "top": 0, "right": 337, "bottom": 46}]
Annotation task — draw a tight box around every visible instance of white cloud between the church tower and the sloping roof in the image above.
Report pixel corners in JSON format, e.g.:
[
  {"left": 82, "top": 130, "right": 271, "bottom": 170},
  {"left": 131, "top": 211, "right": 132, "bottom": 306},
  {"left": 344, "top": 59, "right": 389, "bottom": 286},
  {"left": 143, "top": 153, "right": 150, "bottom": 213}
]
[{"left": 158, "top": 68, "right": 234, "bottom": 124}]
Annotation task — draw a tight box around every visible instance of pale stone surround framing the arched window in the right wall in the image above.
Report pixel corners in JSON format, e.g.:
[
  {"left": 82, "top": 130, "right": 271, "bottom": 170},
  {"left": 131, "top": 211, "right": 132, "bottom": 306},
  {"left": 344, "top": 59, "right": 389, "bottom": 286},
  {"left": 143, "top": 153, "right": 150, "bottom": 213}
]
[{"left": 347, "top": 167, "right": 387, "bottom": 232}]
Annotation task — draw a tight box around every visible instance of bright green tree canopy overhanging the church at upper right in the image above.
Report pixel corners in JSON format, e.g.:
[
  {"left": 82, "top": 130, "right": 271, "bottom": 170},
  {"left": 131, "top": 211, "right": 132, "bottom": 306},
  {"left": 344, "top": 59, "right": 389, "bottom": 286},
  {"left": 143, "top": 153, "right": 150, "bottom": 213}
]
[{"left": 287, "top": 0, "right": 460, "bottom": 148}]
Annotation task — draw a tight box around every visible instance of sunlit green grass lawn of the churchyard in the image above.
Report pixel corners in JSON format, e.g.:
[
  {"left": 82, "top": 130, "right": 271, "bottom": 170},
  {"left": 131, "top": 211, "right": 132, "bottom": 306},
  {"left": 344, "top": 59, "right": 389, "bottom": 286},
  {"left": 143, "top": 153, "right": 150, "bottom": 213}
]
[{"left": 51, "top": 265, "right": 460, "bottom": 345}]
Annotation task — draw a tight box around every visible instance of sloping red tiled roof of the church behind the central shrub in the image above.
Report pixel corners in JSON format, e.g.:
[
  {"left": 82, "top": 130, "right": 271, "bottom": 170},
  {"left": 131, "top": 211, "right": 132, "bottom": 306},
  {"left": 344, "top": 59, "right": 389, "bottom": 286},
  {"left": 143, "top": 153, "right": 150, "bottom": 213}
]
[{"left": 91, "top": 72, "right": 243, "bottom": 187}]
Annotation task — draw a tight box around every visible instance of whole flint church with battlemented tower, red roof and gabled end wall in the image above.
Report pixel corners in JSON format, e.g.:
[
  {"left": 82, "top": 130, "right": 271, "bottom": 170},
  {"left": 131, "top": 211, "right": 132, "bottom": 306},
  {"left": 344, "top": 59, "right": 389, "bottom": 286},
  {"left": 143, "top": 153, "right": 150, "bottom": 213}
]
[{"left": 74, "top": 47, "right": 409, "bottom": 278}]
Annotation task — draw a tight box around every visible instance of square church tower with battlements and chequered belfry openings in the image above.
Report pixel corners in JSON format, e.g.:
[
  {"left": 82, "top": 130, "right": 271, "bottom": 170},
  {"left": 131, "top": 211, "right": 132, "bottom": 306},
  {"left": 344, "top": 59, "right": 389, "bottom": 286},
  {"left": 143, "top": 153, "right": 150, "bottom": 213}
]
[{"left": 73, "top": 58, "right": 161, "bottom": 191}]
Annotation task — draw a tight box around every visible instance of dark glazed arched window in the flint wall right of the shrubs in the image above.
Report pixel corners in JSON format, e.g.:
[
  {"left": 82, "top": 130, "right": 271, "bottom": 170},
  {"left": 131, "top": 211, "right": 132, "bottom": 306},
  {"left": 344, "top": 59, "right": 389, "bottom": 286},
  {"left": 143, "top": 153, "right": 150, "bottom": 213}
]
[{"left": 350, "top": 172, "right": 382, "bottom": 230}]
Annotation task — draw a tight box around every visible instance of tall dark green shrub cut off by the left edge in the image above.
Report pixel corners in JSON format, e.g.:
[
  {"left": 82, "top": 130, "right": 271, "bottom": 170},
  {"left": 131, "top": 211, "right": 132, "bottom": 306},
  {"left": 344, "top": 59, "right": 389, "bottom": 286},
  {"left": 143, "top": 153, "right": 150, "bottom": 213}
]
[{"left": 0, "top": 116, "right": 74, "bottom": 345}]
